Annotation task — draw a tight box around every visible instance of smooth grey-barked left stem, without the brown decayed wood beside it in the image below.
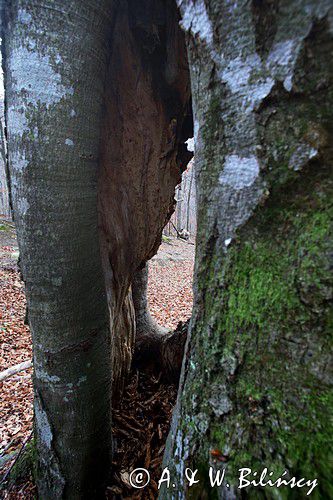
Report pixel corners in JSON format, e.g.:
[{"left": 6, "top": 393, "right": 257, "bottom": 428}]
[{"left": 4, "top": 0, "right": 111, "bottom": 499}]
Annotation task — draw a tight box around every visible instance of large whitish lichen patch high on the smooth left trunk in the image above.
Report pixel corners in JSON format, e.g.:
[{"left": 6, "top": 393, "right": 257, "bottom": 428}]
[{"left": 9, "top": 46, "right": 74, "bottom": 110}]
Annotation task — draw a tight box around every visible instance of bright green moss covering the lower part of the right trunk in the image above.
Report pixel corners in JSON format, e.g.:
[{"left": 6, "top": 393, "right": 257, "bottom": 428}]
[{"left": 185, "top": 167, "right": 333, "bottom": 499}]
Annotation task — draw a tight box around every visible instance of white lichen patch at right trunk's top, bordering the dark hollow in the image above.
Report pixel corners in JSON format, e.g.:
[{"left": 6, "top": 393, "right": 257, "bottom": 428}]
[{"left": 180, "top": 0, "right": 213, "bottom": 45}]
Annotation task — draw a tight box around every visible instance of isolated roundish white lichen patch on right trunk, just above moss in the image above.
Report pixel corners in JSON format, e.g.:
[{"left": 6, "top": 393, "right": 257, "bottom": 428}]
[{"left": 219, "top": 155, "right": 260, "bottom": 190}]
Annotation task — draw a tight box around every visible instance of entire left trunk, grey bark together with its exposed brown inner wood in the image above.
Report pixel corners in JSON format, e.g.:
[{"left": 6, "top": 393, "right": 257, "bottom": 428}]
[{"left": 0, "top": 0, "right": 193, "bottom": 499}]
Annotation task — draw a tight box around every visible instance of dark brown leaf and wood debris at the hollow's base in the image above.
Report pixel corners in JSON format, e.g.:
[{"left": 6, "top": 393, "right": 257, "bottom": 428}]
[{"left": 107, "top": 372, "right": 177, "bottom": 500}]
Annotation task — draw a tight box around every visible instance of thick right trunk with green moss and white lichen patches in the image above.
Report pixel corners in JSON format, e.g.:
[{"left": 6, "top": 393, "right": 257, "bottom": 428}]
[{"left": 160, "top": 0, "right": 333, "bottom": 498}]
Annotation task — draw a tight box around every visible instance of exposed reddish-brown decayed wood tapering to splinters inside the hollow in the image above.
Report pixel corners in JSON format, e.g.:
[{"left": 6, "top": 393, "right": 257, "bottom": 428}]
[{"left": 99, "top": 0, "right": 193, "bottom": 391}]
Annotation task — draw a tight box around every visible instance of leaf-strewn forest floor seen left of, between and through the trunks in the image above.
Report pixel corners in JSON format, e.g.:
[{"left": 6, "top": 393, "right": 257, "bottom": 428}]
[{"left": 0, "top": 224, "right": 194, "bottom": 500}]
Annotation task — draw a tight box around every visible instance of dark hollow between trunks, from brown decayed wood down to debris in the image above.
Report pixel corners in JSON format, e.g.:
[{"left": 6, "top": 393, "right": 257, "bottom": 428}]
[{"left": 99, "top": 0, "right": 193, "bottom": 492}]
